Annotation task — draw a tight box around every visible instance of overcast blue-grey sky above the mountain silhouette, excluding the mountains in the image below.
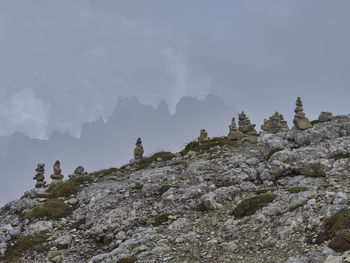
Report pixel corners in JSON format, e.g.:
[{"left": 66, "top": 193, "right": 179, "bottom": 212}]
[{"left": 0, "top": 0, "right": 350, "bottom": 138}]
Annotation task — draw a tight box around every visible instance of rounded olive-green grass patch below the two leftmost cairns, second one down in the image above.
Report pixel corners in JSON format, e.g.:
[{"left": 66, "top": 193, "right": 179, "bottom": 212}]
[{"left": 22, "top": 199, "right": 72, "bottom": 219}]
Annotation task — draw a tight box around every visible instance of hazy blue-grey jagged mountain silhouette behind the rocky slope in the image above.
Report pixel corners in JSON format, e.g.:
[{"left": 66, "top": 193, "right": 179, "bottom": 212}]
[{"left": 0, "top": 95, "right": 237, "bottom": 205}]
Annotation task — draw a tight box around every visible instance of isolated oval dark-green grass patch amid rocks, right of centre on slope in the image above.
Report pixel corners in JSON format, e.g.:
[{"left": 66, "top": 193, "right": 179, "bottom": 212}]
[{"left": 233, "top": 193, "right": 277, "bottom": 218}]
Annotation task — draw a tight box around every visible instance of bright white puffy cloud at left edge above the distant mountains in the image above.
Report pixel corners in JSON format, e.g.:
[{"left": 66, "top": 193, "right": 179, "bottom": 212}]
[{"left": 0, "top": 89, "right": 48, "bottom": 138}]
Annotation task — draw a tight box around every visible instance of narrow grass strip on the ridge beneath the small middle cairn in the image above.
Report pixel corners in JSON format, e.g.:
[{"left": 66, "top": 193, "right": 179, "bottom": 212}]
[{"left": 181, "top": 137, "right": 243, "bottom": 155}]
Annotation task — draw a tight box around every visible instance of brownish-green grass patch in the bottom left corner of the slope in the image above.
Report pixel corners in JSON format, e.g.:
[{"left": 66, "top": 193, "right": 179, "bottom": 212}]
[{"left": 1, "top": 231, "right": 48, "bottom": 263}]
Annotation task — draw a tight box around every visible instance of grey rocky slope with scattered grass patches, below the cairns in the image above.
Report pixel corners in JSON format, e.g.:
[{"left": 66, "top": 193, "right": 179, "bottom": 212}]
[{"left": 0, "top": 115, "right": 350, "bottom": 263}]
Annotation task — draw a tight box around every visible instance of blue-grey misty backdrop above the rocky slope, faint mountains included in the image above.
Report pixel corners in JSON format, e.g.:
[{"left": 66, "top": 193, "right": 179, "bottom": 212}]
[{"left": 0, "top": 0, "right": 350, "bottom": 206}]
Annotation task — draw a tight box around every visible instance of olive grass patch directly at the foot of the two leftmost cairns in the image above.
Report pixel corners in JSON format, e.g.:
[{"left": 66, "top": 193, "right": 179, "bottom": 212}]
[{"left": 47, "top": 175, "right": 93, "bottom": 198}]
